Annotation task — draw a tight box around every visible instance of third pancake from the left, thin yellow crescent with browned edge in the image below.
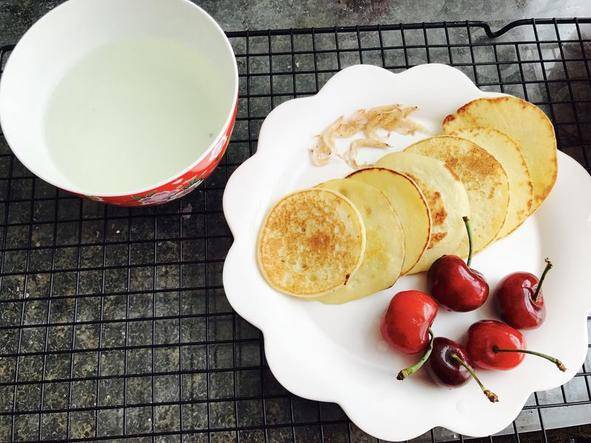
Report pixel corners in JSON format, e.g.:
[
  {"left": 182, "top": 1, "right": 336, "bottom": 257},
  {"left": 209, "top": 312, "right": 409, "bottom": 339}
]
[{"left": 347, "top": 168, "right": 431, "bottom": 274}]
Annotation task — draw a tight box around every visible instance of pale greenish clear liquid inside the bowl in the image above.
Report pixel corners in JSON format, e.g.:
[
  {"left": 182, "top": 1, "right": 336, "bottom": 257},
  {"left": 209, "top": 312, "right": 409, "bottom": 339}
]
[{"left": 45, "top": 38, "right": 231, "bottom": 194}]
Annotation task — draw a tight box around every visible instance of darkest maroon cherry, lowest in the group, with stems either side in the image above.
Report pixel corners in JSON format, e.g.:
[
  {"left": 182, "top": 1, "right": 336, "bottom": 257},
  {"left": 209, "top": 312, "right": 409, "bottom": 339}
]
[{"left": 396, "top": 334, "right": 499, "bottom": 403}]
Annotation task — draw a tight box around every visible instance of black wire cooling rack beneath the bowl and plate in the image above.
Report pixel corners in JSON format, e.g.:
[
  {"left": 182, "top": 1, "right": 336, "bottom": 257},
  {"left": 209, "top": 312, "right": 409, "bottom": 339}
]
[{"left": 0, "top": 19, "right": 591, "bottom": 442}]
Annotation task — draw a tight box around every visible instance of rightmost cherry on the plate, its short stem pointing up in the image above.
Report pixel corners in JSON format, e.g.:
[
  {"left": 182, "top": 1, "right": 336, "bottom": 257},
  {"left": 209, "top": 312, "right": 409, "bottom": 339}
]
[{"left": 494, "top": 259, "right": 552, "bottom": 329}]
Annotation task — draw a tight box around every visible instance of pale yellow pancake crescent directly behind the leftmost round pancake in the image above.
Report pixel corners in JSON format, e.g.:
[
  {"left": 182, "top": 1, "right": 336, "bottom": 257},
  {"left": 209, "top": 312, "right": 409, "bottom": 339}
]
[{"left": 319, "top": 179, "right": 404, "bottom": 303}]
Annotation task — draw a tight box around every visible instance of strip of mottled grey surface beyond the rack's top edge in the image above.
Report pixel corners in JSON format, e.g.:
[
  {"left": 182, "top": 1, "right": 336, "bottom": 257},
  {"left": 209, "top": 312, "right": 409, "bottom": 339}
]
[{"left": 0, "top": 0, "right": 591, "bottom": 44}]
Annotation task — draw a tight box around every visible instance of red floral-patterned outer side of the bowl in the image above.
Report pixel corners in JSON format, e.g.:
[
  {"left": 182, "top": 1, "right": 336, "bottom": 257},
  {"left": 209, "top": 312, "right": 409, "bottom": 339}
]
[{"left": 80, "top": 101, "right": 238, "bottom": 206}]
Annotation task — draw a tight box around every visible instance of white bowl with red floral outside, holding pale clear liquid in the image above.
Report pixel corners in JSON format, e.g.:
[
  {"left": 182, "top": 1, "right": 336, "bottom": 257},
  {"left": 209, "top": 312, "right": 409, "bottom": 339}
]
[{"left": 0, "top": 0, "right": 238, "bottom": 206}]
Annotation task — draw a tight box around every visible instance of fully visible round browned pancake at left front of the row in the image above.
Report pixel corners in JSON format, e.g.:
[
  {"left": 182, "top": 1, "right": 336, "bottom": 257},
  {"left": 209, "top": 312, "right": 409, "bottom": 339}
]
[{"left": 257, "top": 188, "right": 365, "bottom": 297}]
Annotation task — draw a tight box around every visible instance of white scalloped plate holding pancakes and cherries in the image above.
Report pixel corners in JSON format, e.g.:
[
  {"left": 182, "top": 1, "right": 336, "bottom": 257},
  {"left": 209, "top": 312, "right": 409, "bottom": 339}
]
[{"left": 223, "top": 64, "right": 591, "bottom": 440}]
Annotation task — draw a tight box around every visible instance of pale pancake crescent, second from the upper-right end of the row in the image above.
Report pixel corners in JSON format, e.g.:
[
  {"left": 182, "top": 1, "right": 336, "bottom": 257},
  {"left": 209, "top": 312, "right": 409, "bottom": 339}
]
[{"left": 450, "top": 128, "right": 533, "bottom": 238}]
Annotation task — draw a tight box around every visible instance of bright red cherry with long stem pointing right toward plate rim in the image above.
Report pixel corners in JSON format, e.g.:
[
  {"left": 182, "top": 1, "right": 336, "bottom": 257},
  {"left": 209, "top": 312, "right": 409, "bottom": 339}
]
[{"left": 466, "top": 320, "right": 566, "bottom": 372}]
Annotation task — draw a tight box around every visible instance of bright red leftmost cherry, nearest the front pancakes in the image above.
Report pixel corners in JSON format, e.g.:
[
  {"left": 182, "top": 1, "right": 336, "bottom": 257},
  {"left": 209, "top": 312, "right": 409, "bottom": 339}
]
[{"left": 380, "top": 291, "right": 438, "bottom": 354}]
